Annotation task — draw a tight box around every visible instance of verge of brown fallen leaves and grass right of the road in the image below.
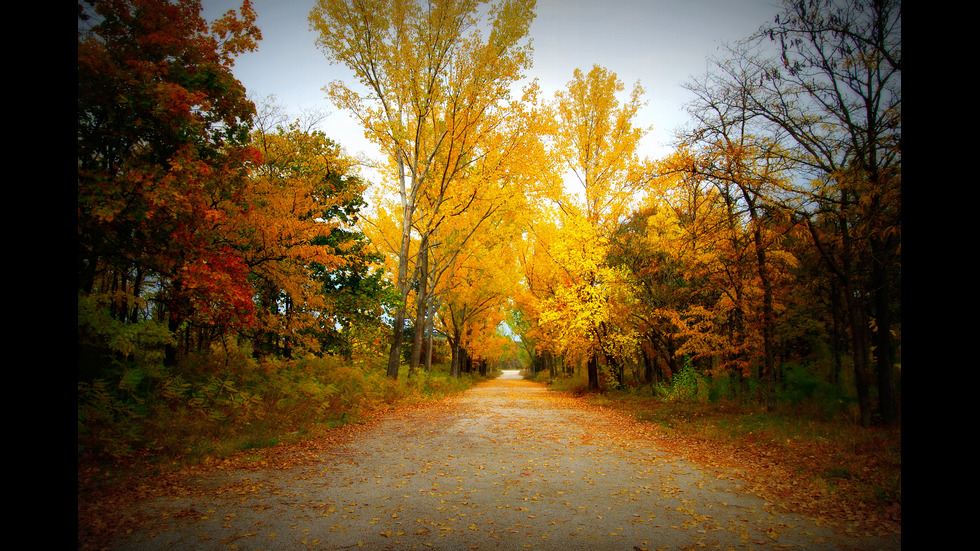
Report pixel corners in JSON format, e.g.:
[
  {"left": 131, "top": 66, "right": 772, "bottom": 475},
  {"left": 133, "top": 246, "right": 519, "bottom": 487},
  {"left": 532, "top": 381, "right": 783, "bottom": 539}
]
[{"left": 590, "top": 397, "right": 902, "bottom": 534}]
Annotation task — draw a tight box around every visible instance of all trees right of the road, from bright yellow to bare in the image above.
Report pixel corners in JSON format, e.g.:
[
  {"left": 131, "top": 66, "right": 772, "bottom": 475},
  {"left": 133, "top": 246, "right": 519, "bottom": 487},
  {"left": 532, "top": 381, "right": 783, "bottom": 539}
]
[{"left": 502, "top": 0, "right": 901, "bottom": 425}]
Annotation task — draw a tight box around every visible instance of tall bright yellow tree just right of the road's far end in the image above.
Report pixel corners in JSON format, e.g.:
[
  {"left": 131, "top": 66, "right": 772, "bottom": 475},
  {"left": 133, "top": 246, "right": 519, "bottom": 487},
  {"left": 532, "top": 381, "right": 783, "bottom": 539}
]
[{"left": 524, "top": 66, "right": 647, "bottom": 388}]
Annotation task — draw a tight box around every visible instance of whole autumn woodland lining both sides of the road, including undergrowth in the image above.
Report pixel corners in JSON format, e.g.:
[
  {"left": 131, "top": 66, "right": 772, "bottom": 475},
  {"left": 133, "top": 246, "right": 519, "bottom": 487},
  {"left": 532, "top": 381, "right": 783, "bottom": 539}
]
[{"left": 77, "top": 0, "right": 902, "bottom": 466}]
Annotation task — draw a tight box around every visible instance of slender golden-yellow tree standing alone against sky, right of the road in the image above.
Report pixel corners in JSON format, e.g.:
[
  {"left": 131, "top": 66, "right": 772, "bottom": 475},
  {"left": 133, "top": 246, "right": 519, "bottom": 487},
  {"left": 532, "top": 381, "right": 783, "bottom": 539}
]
[{"left": 538, "top": 66, "right": 645, "bottom": 389}]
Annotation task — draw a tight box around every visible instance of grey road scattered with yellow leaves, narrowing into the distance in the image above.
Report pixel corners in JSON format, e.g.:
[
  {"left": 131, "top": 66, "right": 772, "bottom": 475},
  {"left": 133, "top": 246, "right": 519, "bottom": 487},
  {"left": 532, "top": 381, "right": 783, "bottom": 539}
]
[{"left": 115, "top": 373, "right": 901, "bottom": 551}]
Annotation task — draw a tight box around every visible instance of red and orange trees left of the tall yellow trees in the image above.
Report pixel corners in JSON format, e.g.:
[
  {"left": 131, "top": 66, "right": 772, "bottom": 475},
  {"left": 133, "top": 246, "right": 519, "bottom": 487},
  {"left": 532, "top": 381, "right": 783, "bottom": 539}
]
[{"left": 77, "top": 0, "right": 386, "bottom": 376}]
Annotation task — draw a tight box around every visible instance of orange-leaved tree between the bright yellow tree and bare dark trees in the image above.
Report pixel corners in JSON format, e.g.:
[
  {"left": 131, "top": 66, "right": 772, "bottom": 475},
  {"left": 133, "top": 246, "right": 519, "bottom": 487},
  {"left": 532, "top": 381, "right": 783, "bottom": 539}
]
[{"left": 628, "top": 160, "right": 747, "bottom": 384}]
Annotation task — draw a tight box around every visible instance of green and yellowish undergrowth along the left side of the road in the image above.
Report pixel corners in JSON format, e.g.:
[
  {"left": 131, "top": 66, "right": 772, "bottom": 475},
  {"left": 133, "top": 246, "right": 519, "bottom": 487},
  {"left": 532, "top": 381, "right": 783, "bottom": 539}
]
[{"left": 78, "top": 343, "right": 486, "bottom": 472}]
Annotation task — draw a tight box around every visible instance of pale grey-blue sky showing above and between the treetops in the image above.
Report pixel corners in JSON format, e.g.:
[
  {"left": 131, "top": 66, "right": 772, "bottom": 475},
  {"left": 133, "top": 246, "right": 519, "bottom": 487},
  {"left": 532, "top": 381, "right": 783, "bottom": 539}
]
[{"left": 202, "top": 0, "right": 780, "bottom": 179}]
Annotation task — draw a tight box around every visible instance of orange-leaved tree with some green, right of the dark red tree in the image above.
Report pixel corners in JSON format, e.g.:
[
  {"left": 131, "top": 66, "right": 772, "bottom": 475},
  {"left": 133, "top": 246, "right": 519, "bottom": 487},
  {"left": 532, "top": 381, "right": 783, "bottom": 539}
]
[{"left": 236, "top": 106, "right": 384, "bottom": 357}]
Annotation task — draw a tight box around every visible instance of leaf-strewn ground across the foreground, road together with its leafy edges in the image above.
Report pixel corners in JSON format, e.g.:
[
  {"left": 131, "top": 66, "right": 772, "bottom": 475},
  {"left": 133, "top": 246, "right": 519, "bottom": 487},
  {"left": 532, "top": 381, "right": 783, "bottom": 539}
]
[{"left": 78, "top": 377, "right": 901, "bottom": 550}]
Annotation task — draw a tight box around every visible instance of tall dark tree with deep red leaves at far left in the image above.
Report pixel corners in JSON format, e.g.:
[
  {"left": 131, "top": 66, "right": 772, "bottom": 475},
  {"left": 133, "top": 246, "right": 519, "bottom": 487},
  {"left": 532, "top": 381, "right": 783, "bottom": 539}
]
[{"left": 78, "top": 0, "right": 261, "bottom": 361}]
